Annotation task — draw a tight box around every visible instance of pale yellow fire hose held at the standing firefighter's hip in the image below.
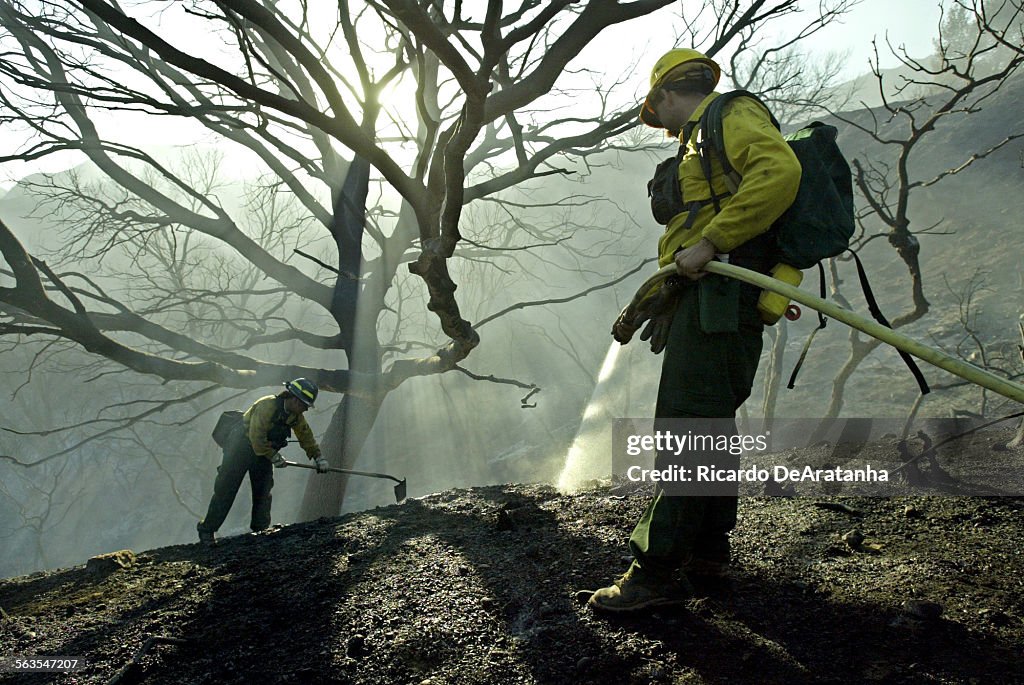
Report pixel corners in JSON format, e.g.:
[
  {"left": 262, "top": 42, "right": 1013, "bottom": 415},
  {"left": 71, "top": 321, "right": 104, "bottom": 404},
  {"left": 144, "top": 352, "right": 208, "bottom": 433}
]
[{"left": 627, "top": 261, "right": 1024, "bottom": 403}]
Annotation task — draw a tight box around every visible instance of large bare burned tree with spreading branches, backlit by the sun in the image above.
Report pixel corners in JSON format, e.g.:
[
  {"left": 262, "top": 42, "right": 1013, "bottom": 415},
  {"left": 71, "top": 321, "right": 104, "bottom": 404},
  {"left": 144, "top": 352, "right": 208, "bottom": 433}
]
[{"left": 0, "top": 0, "right": 684, "bottom": 515}]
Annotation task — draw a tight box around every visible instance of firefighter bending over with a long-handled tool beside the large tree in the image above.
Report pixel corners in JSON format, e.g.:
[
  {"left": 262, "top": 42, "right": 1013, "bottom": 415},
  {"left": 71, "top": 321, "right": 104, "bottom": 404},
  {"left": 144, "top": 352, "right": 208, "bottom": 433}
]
[{"left": 196, "top": 378, "right": 329, "bottom": 544}]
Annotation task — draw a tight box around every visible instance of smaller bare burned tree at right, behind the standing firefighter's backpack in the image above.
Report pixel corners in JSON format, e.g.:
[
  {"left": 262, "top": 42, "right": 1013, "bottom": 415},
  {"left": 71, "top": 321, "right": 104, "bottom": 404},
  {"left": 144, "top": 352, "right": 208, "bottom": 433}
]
[{"left": 811, "top": 4, "right": 1024, "bottom": 417}]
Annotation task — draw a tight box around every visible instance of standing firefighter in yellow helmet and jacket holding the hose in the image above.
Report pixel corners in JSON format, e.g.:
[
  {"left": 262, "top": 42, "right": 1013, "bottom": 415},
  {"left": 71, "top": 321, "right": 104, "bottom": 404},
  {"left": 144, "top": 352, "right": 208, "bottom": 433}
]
[{"left": 589, "top": 48, "right": 801, "bottom": 612}]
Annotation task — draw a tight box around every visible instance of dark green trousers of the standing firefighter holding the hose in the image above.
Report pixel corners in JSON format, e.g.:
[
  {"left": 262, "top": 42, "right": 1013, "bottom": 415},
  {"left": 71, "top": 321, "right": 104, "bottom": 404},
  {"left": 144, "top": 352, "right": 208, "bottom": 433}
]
[{"left": 630, "top": 275, "right": 764, "bottom": 575}]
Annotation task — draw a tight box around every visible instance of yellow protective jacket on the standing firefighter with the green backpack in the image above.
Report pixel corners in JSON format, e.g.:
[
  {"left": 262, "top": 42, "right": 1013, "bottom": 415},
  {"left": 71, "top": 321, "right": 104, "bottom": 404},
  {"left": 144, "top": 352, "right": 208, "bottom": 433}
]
[{"left": 657, "top": 92, "right": 801, "bottom": 266}]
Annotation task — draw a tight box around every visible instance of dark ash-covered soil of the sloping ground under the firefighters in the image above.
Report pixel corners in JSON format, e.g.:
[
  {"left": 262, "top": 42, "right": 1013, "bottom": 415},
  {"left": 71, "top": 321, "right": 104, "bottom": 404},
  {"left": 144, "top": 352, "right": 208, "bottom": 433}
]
[{"left": 0, "top": 433, "right": 1024, "bottom": 685}]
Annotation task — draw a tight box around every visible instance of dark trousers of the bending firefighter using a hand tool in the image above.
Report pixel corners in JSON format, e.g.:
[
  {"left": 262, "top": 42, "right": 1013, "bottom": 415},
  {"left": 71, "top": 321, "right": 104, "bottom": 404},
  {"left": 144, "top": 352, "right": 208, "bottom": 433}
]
[{"left": 196, "top": 429, "right": 273, "bottom": 532}]
